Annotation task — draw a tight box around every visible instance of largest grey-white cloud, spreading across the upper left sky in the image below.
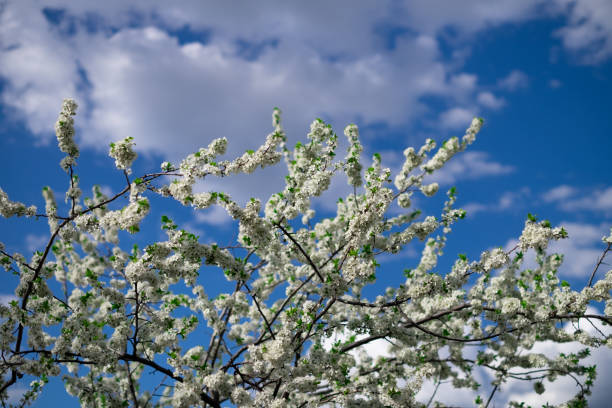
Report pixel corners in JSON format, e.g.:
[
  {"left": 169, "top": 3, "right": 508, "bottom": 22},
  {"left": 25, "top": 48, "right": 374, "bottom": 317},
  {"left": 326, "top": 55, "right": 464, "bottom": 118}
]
[{"left": 0, "top": 1, "right": 475, "bottom": 160}]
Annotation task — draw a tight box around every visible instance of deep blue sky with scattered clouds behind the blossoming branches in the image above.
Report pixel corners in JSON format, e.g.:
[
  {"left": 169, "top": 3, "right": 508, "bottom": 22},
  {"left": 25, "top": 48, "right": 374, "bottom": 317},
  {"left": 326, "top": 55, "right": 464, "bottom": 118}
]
[{"left": 0, "top": 0, "right": 612, "bottom": 406}]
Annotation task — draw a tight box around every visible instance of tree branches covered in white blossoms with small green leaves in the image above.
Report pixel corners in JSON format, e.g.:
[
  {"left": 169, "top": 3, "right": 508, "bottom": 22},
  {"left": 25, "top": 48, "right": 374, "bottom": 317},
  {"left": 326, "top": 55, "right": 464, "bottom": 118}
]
[{"left": 0, "top": 99, "right": 612, "bottom": 407}]
